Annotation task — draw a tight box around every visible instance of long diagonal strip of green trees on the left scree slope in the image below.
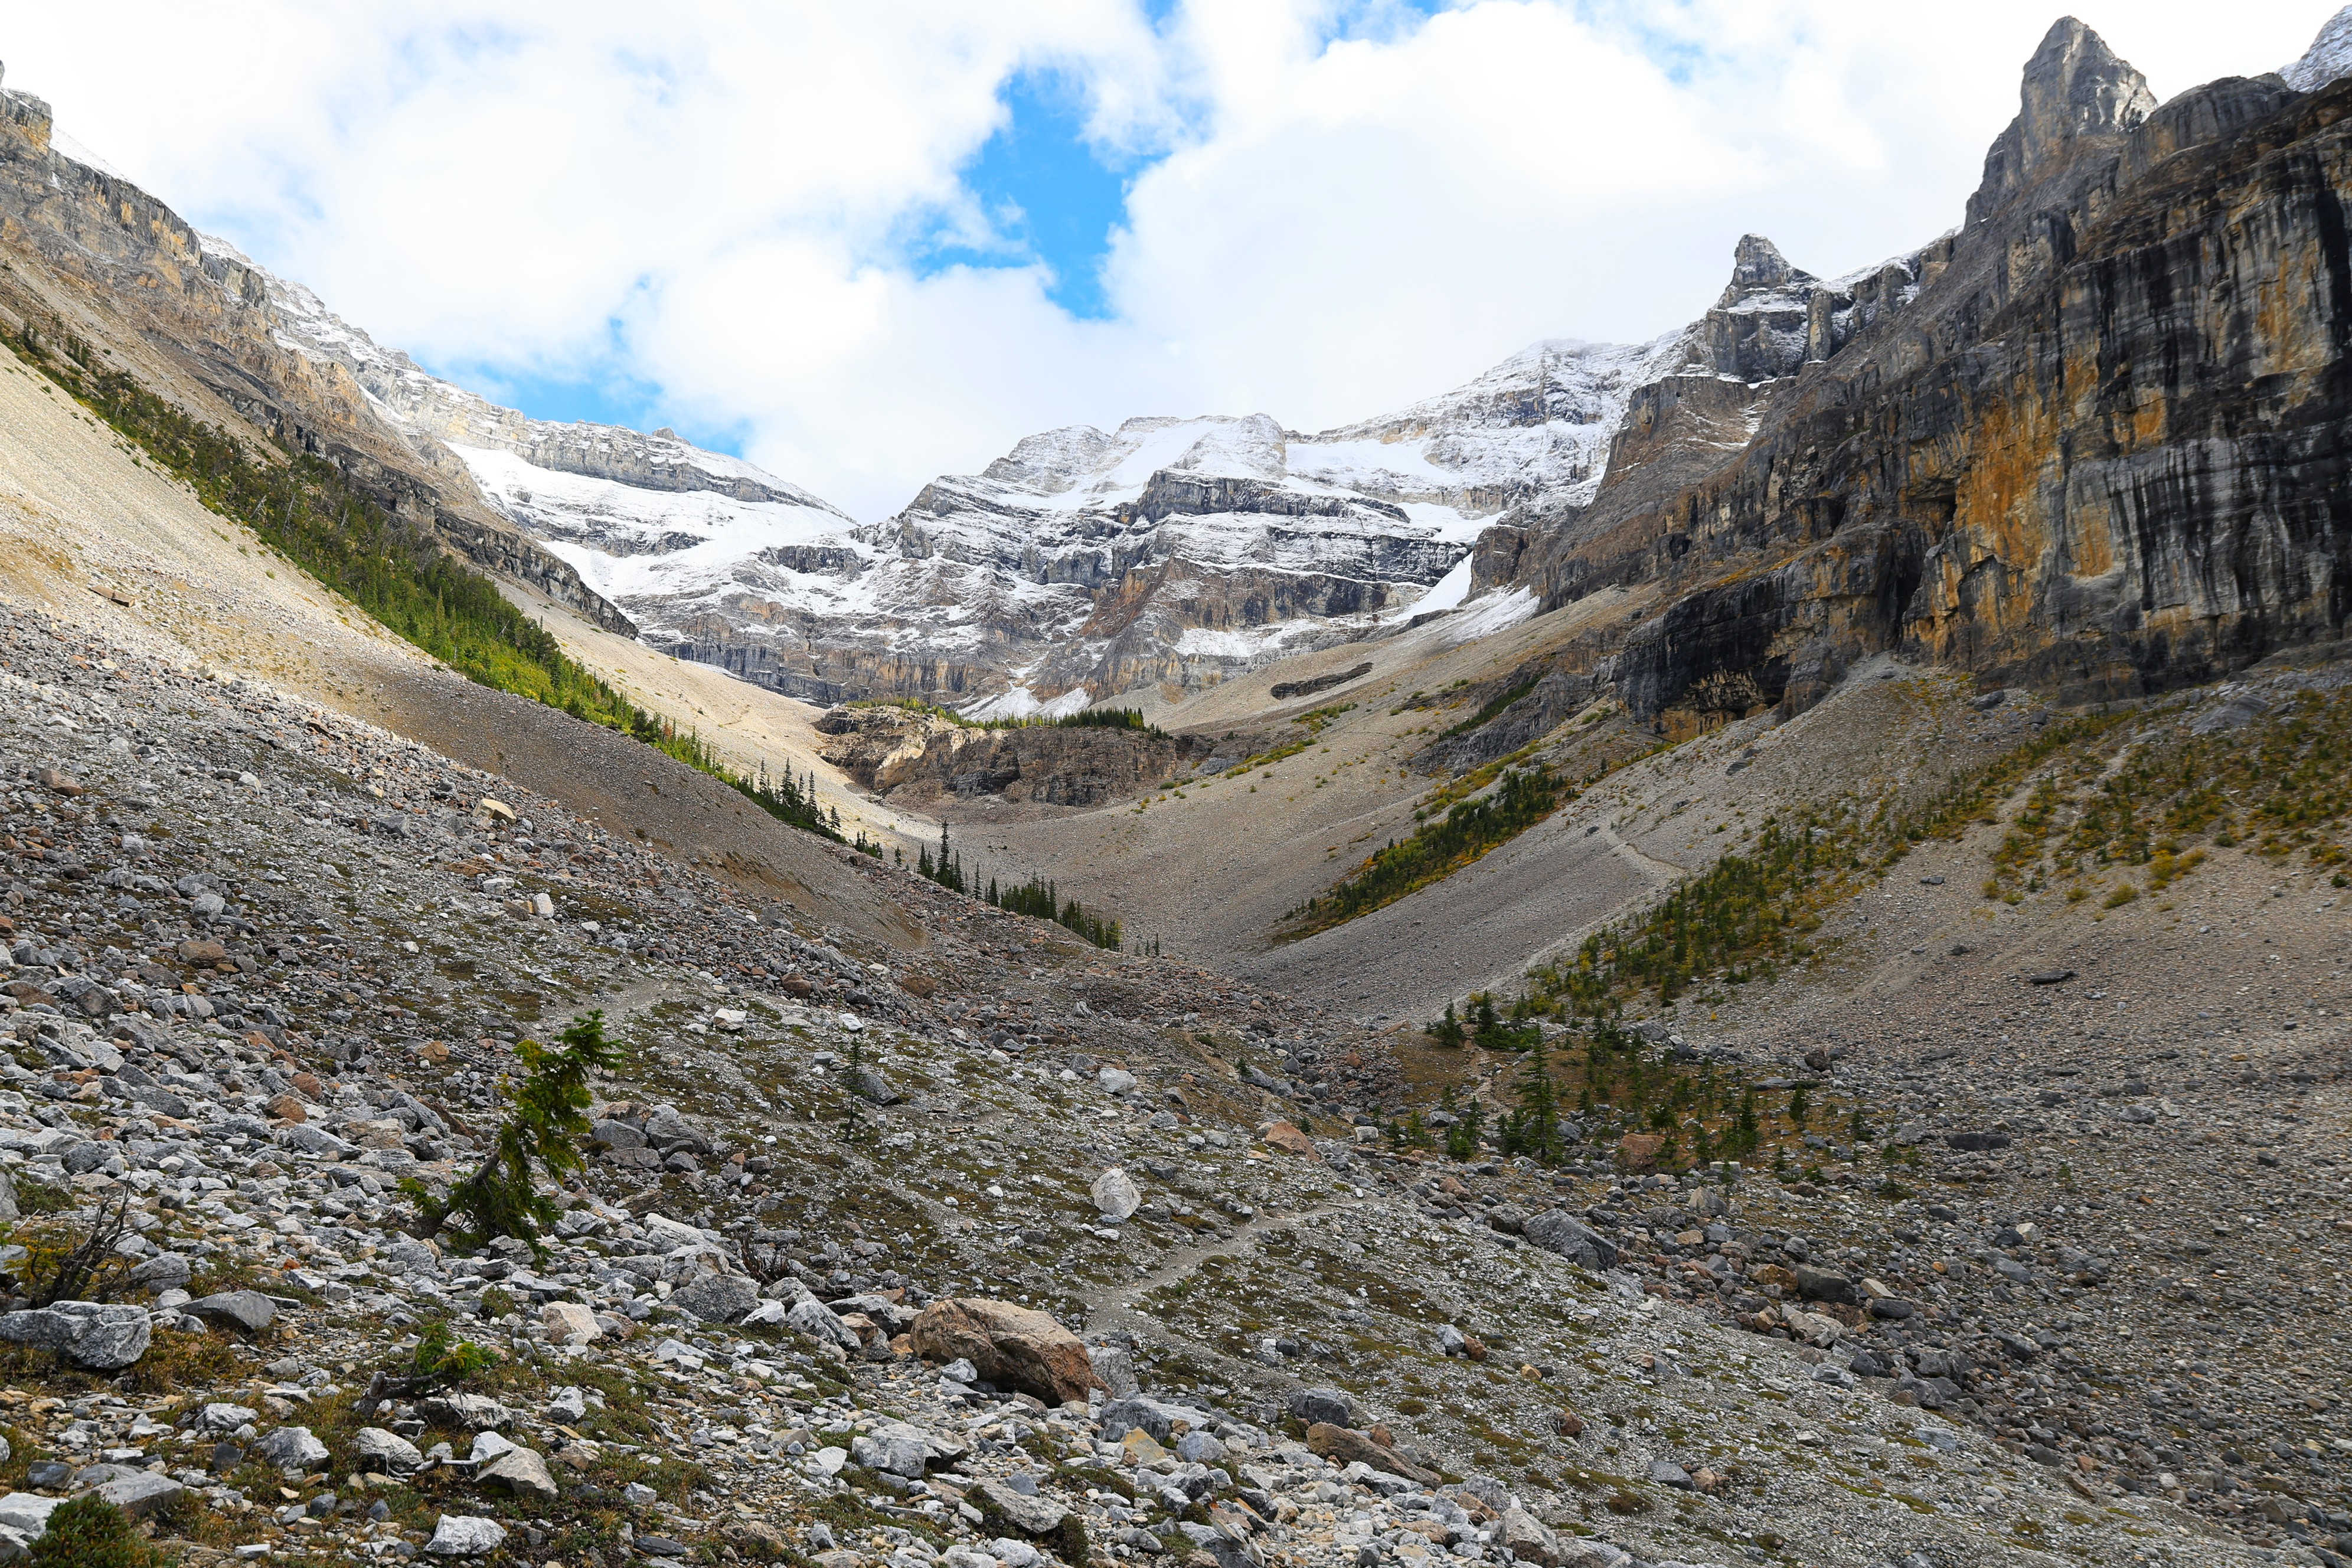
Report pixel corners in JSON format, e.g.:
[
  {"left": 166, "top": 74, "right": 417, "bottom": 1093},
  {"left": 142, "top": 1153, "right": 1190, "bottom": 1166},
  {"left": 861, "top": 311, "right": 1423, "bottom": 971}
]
[{"left": 0, "top": 334, "right": 847, "bottom": 853}]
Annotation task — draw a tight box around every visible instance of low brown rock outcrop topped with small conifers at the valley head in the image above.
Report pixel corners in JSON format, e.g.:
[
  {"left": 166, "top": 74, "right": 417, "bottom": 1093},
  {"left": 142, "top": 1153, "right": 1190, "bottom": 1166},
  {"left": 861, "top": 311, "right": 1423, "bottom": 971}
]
[{"left": 816, "top": 703, "right": 1204, "bottom": 806}]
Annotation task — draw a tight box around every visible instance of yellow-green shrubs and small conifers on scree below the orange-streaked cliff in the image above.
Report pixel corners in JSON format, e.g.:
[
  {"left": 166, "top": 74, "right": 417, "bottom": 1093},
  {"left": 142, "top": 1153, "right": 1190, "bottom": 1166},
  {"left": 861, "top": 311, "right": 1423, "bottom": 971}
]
[{"left": 1390, "top": 689, "right": 2352, "bottom": 1182}]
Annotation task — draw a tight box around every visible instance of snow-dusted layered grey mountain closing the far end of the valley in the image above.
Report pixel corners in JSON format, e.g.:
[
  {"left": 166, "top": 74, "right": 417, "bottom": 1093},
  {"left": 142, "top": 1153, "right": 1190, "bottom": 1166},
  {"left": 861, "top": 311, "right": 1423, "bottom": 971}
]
[{"left": 165, "top": 217, "right": 1684, "bottom": 717}]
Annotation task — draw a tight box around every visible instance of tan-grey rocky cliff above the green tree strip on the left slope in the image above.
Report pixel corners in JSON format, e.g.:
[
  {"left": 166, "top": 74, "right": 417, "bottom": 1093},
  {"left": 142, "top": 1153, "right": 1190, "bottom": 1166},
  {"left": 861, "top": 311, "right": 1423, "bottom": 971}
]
[{"left": 0, "top": 67, "right": 631, "bottom": 630}]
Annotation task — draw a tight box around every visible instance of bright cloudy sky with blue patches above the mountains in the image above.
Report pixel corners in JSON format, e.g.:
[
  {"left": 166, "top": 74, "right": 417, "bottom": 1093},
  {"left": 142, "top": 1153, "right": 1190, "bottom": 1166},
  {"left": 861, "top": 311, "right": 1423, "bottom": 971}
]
[{"left": 0, "top": 0, "right": 2333, "bottom": 520}]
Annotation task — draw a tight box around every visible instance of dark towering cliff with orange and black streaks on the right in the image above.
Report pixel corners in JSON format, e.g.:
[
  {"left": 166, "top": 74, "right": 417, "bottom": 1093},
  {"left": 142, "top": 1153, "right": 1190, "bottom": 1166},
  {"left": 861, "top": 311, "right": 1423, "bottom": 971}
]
[{"left": 1479, "top": 19, "right": 2352, "bottom": 721}]
